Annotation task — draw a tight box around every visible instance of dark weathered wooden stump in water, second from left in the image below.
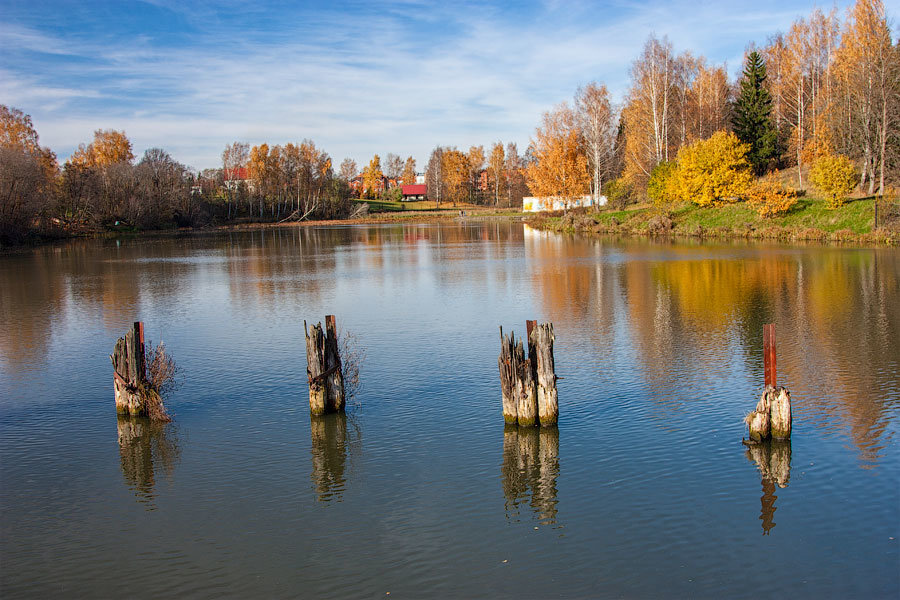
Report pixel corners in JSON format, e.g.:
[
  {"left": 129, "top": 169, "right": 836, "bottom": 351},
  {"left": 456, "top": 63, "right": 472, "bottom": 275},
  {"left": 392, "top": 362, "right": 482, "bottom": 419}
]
[{"left": 303, "top": 315, "right": 345, "bottom": 415}]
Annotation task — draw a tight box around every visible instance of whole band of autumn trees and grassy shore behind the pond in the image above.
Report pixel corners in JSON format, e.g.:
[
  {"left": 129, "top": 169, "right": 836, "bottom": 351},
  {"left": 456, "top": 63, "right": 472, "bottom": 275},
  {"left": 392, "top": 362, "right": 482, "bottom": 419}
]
[{"left": 0, "top": 0, "right": 900, "bottom": 248}]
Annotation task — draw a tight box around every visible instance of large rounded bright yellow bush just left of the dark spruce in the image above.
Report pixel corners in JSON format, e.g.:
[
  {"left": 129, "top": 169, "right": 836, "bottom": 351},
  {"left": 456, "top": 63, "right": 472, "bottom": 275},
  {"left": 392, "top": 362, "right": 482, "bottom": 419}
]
[{"left": 673, "top": 131, "right": 753, "bottom": 206}]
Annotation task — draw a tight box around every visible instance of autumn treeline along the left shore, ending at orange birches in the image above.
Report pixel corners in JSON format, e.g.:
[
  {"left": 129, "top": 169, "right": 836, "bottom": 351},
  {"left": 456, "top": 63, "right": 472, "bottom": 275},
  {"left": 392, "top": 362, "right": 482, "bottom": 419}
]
[{"left": 0, "top": 111, "right": 354, "bottom": 245}]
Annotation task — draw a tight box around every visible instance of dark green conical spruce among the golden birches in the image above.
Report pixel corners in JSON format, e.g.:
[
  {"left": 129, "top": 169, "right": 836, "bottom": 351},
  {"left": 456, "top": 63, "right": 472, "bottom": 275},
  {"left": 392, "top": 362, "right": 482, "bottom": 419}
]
[{"left": 731, "top": 50, "right": 778, "bottom": 175}]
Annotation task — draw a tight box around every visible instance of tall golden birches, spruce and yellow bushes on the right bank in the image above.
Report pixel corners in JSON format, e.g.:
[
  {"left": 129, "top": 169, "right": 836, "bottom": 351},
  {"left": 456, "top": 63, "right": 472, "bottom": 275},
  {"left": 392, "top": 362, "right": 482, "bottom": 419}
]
[{"left": 526, "top": 0, "right": 900, "bottom": 211}]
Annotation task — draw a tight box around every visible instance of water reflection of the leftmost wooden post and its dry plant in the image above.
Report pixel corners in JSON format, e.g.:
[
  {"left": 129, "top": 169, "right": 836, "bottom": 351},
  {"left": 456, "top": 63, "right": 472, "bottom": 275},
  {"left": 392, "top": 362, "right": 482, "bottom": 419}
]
[{"left": 117, "top": 415, "right": 181, "bottom": 502}]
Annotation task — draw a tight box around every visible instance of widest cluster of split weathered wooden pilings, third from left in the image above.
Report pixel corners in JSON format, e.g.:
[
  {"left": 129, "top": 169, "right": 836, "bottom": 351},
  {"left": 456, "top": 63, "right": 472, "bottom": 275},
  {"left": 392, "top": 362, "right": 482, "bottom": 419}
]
[{"left": 497, "top": 321, "right": 559, "bottom": 427}]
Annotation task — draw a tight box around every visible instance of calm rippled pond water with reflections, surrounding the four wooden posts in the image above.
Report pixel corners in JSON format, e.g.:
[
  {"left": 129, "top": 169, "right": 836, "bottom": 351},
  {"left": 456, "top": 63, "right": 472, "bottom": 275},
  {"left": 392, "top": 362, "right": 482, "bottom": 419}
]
[{"left": 0, "top": 223, "right": 900, "bottom": 598}]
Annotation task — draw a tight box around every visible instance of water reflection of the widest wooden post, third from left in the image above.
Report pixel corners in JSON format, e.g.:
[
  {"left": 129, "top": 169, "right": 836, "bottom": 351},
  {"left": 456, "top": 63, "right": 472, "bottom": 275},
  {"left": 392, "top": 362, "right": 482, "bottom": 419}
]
[{"left": 500, "top": 425, "right": 559, "bottom": 524}]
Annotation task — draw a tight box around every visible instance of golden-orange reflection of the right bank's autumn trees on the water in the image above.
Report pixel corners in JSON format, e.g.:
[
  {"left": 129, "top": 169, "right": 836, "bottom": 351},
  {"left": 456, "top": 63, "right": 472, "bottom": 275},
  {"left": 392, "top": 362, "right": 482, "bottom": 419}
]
[{"left": 526, "top": 234, "right": 900, "bottom": 466}]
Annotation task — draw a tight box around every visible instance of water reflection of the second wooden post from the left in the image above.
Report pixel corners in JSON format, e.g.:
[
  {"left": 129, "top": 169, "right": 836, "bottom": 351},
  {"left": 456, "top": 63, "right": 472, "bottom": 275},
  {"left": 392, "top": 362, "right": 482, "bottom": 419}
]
[{"left": 309, "top": 412, "right": 347, "bottom": 502}]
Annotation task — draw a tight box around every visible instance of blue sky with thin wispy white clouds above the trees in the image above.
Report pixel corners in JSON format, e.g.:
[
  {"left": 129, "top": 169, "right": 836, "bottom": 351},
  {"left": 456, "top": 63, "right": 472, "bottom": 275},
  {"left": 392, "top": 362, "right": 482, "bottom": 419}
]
[{"left": 0, "top": 0, "right": 888, "bottom": 169}]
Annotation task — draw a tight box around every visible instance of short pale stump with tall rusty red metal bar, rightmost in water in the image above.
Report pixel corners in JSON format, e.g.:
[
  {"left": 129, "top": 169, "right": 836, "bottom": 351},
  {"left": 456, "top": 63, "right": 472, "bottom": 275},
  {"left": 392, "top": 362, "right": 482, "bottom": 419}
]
[{"left": 746, "top": 324, "right": 792, "bottom": 444}]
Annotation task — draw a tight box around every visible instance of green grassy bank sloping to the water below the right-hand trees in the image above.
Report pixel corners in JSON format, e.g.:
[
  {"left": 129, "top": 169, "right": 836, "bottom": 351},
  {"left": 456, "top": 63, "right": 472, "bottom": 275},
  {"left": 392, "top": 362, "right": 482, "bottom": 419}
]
[{"left": 529, "top": 196, "right": 900, "bottom": 245}]
